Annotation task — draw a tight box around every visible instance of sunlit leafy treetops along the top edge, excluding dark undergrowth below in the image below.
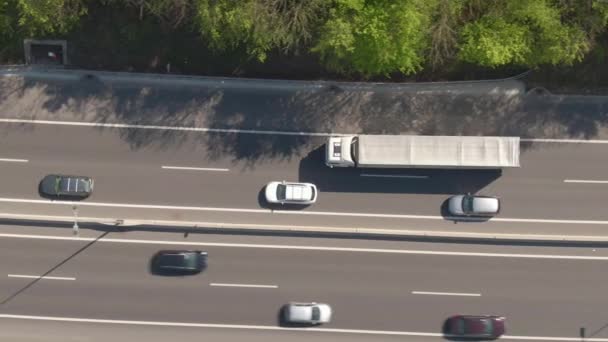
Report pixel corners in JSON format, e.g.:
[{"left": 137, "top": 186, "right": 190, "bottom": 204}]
[{"left": 0, "top": 0, "right": 608, "bottom": 78}]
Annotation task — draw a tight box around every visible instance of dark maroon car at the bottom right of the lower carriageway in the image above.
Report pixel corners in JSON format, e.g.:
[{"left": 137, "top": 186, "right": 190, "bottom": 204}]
[{"left": 445, "top": 315, "right": 505, "bottom": 339}]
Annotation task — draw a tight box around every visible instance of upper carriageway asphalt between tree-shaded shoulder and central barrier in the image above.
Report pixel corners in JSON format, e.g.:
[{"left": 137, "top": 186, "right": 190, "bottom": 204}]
[{"left": 0, "top": 124, "right": 608, "bottom": 235}]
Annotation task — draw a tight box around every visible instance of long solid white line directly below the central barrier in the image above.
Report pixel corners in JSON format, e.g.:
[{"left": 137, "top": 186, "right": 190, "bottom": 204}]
[{"left": 0, "top": 234, "right": 608, "bottom": 261}]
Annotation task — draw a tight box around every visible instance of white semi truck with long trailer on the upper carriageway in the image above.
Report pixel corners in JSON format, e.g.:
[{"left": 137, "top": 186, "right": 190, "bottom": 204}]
[{"left": 325, "top": 135, "right": 519, "bottom": 169}]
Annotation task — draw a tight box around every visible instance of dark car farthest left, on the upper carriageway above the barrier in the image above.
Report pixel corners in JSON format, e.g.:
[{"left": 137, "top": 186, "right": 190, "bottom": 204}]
[{"left": 39, "top": 175, "right": 93, "bottom": 199}]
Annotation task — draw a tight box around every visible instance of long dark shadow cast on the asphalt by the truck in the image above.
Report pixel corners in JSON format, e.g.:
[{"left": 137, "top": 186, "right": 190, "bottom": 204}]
[{"left": 299, "top": 145, "right": 502, "bottom": 195}]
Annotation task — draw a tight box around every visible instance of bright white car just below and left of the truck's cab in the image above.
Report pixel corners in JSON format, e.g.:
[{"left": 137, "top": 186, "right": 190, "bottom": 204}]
[{"left": 265, "top": 181, "right": 317, "bottom": 204}]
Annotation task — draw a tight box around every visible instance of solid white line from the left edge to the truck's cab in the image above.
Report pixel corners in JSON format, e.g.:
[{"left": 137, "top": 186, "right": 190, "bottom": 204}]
[{"left": 0, "top": 118, "right": 346, "bottom": 137}]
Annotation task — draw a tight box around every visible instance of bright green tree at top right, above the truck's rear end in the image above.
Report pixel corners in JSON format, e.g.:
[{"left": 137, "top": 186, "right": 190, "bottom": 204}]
[{"left": 459, "top": 0, "right": 591, "bottom": 67}]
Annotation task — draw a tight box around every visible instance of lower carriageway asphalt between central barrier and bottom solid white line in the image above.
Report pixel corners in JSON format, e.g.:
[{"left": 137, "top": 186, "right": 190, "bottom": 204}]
[{"left": 0, "top": 227, "right": 608, "bottom": 338}]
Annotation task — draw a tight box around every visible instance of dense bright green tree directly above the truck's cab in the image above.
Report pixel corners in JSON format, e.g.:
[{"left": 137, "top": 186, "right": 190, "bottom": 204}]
[{"left": 312, "top": 0, "right": 437, "bottom": 77}]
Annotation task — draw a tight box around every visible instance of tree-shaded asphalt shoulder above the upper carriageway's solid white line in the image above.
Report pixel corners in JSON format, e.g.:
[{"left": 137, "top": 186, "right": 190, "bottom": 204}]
[{"left": 0, "top": 70, "right": 608, "bottom": 168}]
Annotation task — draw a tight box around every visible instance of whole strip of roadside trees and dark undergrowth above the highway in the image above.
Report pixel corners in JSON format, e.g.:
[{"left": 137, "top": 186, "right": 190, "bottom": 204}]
[{"left": 0, "top": 0, "right": 608, "bottom": 88}]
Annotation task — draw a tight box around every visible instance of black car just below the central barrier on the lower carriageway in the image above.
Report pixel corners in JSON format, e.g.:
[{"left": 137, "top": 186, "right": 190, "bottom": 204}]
[{"left": 152, "top": 251, "right": 207, "bottom": 274}]
